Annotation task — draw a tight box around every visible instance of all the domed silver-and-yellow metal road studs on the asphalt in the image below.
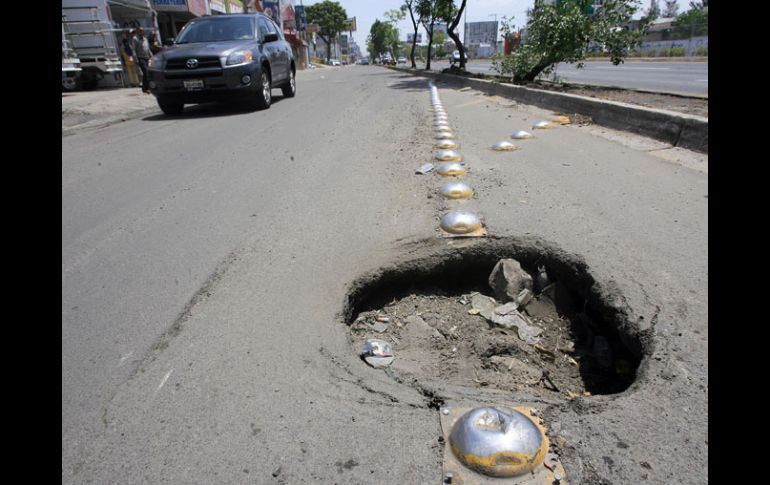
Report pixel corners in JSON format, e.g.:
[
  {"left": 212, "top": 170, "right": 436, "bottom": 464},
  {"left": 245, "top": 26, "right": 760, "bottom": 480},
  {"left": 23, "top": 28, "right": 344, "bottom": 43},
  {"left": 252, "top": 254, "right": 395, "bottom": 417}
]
[{"left": 418, "top": 82, "right": 569, "bottom": 485}]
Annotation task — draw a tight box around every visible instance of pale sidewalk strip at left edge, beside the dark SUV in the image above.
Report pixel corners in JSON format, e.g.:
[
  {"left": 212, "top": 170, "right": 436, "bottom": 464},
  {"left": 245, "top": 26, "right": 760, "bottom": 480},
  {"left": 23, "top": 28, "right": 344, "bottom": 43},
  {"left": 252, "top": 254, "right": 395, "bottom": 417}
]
[{"left": 61, "top": 88, "right": 160, "bottom": 136}]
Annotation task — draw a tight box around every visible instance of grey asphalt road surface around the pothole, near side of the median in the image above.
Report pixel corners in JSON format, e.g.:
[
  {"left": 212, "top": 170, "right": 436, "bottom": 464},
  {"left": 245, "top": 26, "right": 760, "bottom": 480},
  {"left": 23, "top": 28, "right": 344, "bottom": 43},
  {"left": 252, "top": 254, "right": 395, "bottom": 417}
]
[{"left": 62, "top": 66, "right": 708, "bottom": 484}]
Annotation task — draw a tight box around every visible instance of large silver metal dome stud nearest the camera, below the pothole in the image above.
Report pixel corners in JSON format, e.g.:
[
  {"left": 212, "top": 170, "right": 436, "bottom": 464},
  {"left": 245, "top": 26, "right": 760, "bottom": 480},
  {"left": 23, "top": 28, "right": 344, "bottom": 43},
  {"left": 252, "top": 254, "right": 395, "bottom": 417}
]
[{"left": 449, "top": 407, "right": 548, "bottom": 478}]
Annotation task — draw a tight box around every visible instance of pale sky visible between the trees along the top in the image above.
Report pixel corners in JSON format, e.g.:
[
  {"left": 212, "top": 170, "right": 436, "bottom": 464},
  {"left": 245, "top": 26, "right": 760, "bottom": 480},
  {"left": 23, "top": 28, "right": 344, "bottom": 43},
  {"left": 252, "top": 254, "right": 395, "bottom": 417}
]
[{"left": 294, "top": 0, "right": 690, "bottom": 48}]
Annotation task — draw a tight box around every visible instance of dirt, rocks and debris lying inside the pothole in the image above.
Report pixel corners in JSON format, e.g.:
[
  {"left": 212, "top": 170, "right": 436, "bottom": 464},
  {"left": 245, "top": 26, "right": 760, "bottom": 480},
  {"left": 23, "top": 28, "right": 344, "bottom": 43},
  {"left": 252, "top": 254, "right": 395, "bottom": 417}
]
[{"left": 351, "top": 260, "right": 635, "bottom": 399}]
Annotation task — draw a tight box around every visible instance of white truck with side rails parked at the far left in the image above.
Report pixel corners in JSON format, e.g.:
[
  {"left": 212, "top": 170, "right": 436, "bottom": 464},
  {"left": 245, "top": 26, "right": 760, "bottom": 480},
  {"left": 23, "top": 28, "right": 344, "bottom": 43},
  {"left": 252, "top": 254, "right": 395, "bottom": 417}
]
[{"left": 62, "top": 0, "right": 156, "bottom": 90}]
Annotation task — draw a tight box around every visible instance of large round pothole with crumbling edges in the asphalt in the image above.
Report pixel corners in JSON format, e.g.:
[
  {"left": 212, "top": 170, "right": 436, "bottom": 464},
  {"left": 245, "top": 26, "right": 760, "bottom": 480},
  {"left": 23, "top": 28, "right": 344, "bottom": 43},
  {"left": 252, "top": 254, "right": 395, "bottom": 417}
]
[{"left": 343, "top": 240, "right": 645, "bottom": 399}]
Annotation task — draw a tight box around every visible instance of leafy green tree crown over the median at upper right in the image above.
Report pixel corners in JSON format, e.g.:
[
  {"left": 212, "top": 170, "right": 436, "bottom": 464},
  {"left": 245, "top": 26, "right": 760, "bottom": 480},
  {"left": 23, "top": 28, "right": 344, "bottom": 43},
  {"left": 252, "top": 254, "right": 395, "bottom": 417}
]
[{"left": 514, "top": 0, "right": 650, "bottom": 82}]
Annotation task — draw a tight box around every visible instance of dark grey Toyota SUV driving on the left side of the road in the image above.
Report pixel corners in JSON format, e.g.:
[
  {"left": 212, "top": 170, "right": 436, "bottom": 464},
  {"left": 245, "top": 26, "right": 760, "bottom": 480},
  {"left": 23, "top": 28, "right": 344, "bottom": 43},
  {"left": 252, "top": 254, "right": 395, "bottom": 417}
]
[{"left": 148, "top": 13, "right": 297, "bottom": 115}]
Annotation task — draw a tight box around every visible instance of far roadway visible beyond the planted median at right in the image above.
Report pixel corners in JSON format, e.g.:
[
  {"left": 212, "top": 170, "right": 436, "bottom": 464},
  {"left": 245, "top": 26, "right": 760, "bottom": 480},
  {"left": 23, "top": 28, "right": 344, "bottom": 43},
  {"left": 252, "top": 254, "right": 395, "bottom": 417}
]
[{"left": 431, "top": 60, "right": 708, "bottom": 96}]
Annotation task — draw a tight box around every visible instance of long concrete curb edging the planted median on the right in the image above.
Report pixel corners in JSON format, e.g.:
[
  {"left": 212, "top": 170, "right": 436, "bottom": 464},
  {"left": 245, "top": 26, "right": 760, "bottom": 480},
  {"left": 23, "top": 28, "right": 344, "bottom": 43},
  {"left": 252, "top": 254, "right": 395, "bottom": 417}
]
[{"left": 388, "top": 66, "right": 708, "bottom": 153}]
